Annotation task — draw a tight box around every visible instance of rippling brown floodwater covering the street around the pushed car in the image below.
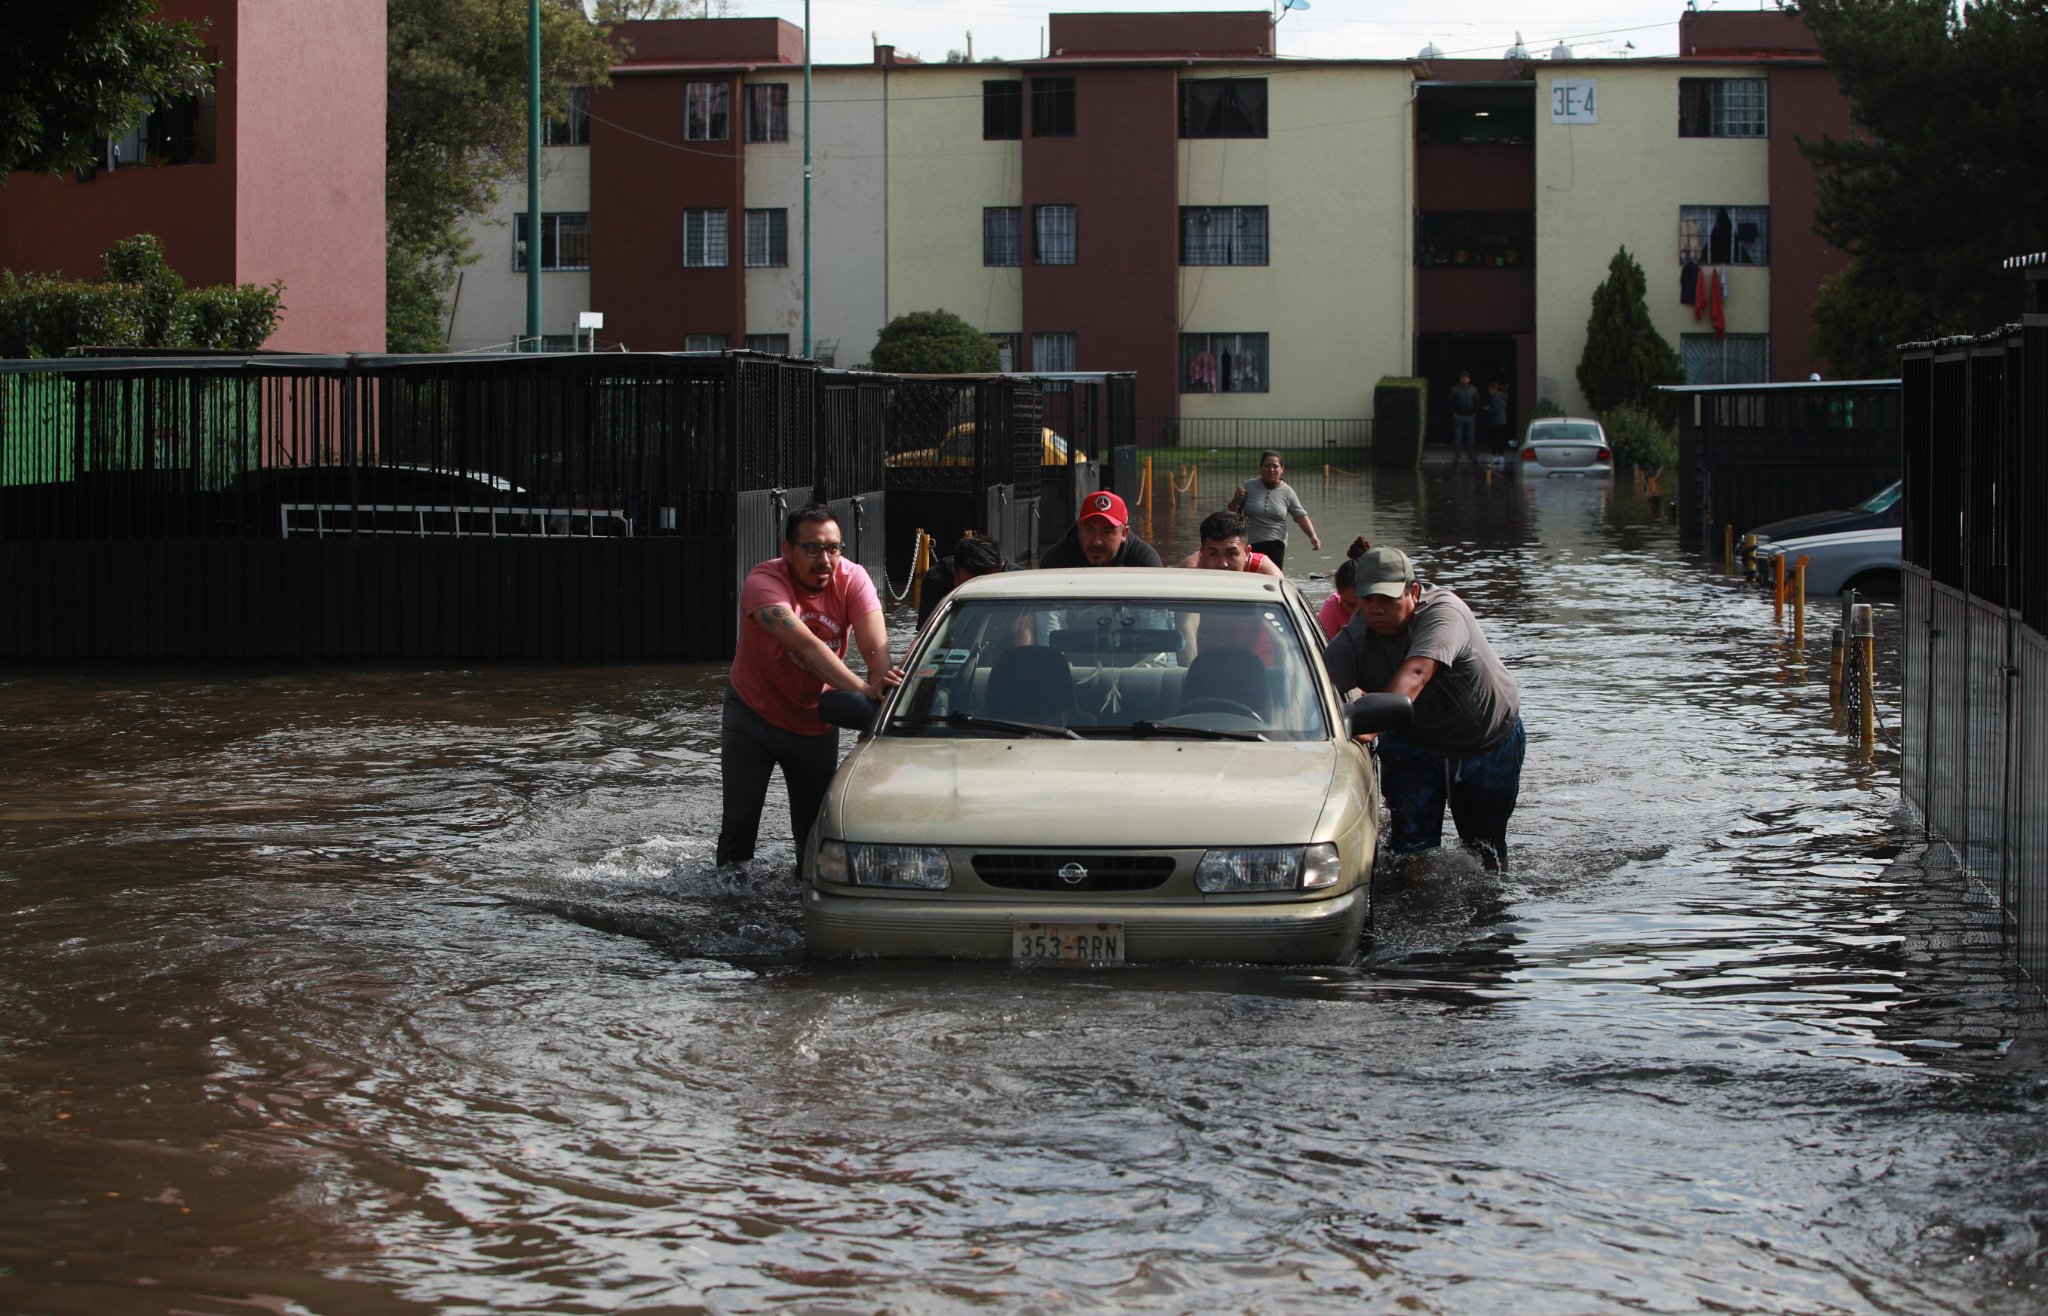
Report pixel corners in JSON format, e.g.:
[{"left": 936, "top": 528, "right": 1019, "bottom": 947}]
[{"left": 0, "top": 467, "right": 2048, "bottom": 1316}]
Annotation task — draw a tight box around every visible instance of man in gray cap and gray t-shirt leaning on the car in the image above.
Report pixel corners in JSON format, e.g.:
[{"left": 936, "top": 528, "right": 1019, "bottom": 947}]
[{"left": 1323, "top": 549, "right": 1528, "bottom": 868}]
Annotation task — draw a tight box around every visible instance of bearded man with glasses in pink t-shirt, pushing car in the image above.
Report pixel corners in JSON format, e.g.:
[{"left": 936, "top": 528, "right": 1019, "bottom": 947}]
[{"left": 719, "top": 503, "right": 903, "bottom": 864}]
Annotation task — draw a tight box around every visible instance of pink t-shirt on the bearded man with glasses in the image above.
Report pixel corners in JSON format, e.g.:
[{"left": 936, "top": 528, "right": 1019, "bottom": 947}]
[{"left": 731, "top": 557, "right": 883, "bottom": 735}]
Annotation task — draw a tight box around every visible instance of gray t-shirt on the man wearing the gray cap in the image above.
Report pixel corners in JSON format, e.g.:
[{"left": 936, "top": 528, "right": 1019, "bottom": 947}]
[{"left": 1323, "top": 585, "right": 1522, "bottom": 759}]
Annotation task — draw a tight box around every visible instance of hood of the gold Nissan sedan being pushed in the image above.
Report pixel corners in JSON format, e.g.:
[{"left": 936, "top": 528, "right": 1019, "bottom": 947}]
[{"left": 831, "top": 737, "right": 1352, "bottom": 849}]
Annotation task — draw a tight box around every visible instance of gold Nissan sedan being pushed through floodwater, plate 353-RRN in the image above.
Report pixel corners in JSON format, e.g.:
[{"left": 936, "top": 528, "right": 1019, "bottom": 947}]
[{"left": 803, "top": 567, "right": 1413, "bottom": 964}]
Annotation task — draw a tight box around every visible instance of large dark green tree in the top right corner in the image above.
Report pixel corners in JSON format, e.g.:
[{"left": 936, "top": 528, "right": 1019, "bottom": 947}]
[{"left": 1800, "top": 0, "right": 2048, "bottom": 377}]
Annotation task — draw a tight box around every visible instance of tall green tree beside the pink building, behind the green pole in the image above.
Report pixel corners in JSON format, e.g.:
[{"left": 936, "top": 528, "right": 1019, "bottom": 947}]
[{"left": 385, "top": 0, "right": 614, "bottom": 352}]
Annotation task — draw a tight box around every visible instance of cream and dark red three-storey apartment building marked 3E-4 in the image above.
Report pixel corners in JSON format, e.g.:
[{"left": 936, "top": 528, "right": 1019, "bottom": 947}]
[{"left": 455, "top": 12, "right": 1847, "bottom": 437}]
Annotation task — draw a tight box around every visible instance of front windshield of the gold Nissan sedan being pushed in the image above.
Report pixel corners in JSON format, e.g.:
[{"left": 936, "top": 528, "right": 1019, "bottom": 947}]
[{"left": 883, "top": 598, "right": 1331, "bottom": 741}]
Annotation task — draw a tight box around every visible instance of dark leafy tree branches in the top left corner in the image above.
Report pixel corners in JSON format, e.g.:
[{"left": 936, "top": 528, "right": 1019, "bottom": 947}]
[{"left": 0, "top": 0, "right": 213, "bottom": 184}]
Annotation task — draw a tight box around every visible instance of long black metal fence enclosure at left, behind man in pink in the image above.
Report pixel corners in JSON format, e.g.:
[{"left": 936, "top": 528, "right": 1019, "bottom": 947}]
[{"left": 0, "top": 352, "right": 1089, "bottom": 661}]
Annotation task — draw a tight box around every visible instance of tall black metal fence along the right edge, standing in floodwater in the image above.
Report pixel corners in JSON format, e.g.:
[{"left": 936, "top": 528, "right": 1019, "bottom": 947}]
[{"left": 1901, "top": 315, "right": 2048, "bottom": 982}]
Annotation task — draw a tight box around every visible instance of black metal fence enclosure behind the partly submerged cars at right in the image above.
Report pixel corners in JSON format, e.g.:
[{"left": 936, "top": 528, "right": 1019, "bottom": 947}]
[{"left": 1669, "top": 381, "right": 1901, "bottom": 551}]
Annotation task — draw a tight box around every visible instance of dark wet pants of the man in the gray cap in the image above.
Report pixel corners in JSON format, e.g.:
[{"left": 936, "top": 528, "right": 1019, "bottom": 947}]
[{"left": 1380, "top": 718, "right": 1528, "bottom": 868}]
